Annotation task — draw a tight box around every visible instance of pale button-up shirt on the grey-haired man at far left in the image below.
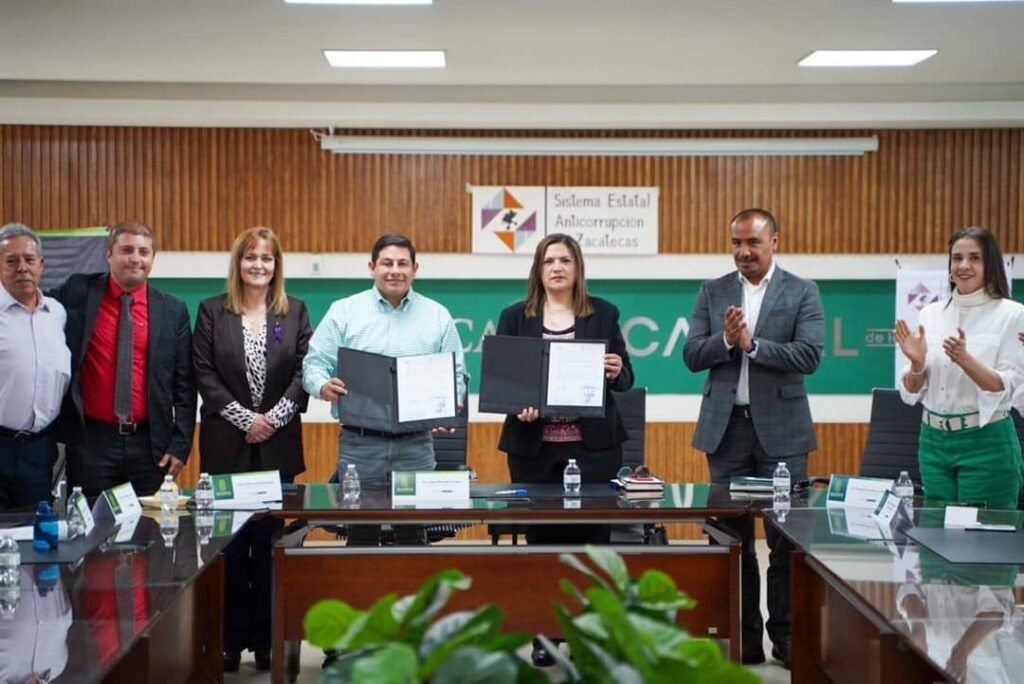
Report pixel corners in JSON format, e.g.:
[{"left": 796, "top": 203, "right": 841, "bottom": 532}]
[{"left": 0, "top": 287, "right": 71, "bottom": 432}]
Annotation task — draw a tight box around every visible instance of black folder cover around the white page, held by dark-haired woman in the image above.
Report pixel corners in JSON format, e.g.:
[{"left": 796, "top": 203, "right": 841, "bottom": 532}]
[{"left": 479, "top": 335, "right": 608, "bottom": 418}]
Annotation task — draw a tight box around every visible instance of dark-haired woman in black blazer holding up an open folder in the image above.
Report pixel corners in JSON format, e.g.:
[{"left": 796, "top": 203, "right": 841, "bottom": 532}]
[{"left": 498, "top": 233, "right": 633, "bottom": 544}]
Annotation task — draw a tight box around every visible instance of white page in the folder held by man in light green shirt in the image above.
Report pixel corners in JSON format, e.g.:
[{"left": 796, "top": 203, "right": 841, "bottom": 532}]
[{"left": 396, "top": 352, "right": 456, "bottom": 423}]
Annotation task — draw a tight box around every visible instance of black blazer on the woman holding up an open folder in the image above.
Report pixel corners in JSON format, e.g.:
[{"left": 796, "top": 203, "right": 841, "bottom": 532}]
[{"left": 498, "top": 297, "right": 633, "bottom": 457}]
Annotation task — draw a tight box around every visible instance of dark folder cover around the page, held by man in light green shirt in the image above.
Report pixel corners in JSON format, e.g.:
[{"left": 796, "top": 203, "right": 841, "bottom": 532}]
[{"left": 338, "top": 347, "right": 459, "bottom": 433}]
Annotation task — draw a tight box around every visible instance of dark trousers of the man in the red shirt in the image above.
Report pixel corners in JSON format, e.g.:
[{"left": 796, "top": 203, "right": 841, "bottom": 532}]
[{"left": 68, "top": 418, "right": 167, "bottom": 497}]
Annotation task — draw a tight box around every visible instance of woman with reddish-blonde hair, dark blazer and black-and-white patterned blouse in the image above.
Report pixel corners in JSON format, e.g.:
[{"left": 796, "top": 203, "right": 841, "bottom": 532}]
[{"left": 193, "top": 227, "right": 312, "bottom": 672}]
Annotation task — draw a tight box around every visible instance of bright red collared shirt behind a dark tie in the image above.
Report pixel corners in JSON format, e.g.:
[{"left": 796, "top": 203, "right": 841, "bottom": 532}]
[{"left": 81, "top": 277, "right": 150, "bottom": 423}]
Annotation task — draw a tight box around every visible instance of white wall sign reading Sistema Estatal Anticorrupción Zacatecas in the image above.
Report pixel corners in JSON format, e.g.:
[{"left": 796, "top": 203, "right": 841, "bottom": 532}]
[{"left": 472, "top": 185, "right": 659, "bottom": 256}]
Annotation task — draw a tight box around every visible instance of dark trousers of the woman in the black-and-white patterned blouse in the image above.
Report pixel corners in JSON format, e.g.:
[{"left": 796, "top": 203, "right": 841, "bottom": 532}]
[{"left": 224, "top": 446, "right": 293, "bottom": 652}]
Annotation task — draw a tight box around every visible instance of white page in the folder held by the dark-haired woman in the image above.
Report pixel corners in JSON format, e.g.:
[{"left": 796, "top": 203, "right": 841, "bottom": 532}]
[{"left": 548, "top": 342, "right": 604, "bottom": 407}]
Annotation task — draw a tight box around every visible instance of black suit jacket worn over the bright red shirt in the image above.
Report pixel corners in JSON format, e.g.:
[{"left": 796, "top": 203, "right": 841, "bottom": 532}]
[{"left": 48, "top": 273, "right": 196, "bottom": 462}]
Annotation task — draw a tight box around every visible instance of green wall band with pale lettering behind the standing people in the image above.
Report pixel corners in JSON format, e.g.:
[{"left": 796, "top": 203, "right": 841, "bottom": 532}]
[{"left": 153, "top": 279, "right": 1024, "bottom": 394}]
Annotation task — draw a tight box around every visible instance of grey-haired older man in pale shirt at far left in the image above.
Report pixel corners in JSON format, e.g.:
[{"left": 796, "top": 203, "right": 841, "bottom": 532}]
[{"left": 0, "top": 223, "right": 71, "bottom": 511}]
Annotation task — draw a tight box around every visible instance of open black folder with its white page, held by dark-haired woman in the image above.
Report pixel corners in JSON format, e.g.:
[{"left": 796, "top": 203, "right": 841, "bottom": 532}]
[{"left": 480, "top": 335, "right": 608, "bottom": 417}]
